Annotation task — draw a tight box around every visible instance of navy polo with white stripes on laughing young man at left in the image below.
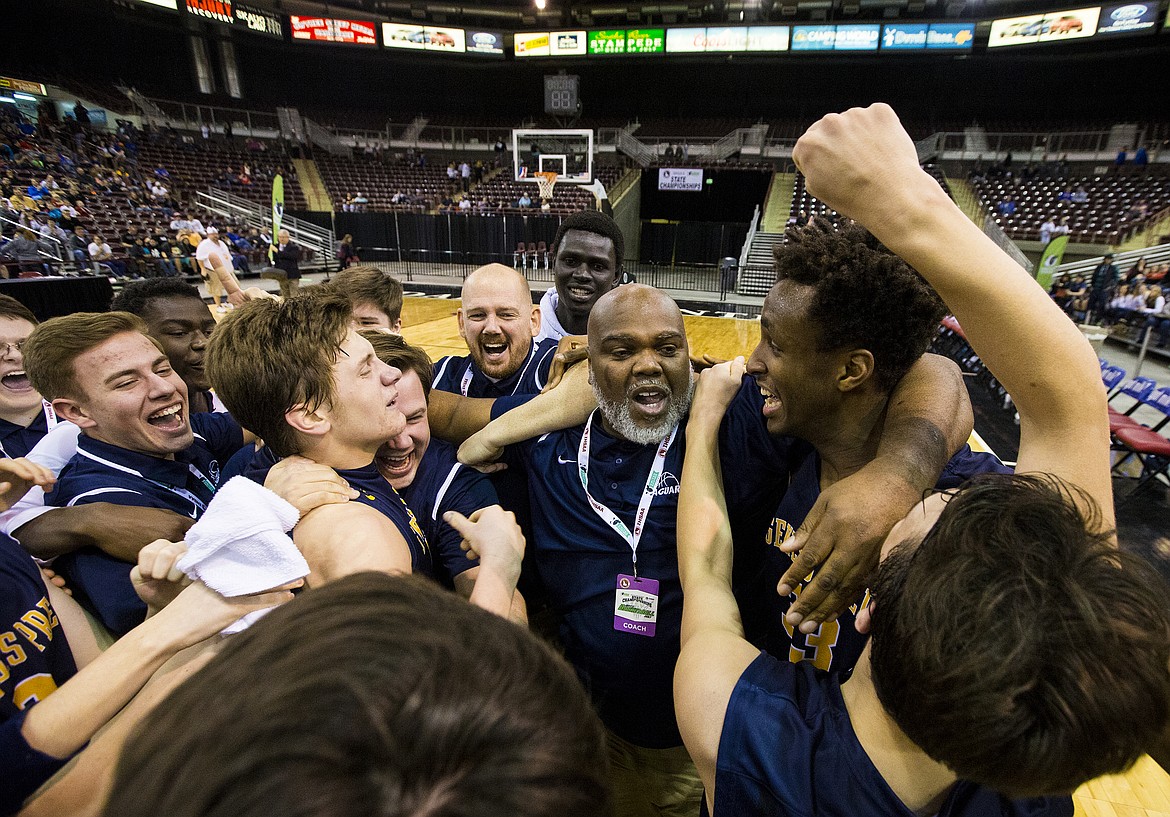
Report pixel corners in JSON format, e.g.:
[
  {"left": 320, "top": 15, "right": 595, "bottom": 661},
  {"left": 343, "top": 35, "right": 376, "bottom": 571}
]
[{"left": 44, "top": 413, "right": 243, "bottom": 636}]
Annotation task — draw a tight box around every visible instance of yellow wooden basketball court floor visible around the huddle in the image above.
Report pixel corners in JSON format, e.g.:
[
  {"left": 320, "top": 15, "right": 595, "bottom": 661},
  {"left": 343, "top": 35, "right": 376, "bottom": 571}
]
[{"left": 225, "top": 297, "right": 1170, "bottom": 817}]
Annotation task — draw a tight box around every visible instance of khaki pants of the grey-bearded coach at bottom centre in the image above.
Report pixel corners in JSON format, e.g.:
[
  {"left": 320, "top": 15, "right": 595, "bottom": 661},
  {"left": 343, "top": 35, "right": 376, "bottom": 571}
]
[{"left": 606, "top": 730, "right": 703, "bottom": 817}]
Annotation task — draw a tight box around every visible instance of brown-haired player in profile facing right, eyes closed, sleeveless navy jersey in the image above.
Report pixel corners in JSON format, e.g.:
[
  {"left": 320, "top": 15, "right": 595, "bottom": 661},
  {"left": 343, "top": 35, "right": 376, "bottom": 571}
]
[{"left": 207, "top": 291, "right": 545, "bottom": 615}]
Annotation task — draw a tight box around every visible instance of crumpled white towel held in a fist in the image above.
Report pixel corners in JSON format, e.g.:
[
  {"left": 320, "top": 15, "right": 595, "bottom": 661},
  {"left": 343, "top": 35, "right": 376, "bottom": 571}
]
[{"left": 178, "top": 476, "right": 309, "bottom": 596}]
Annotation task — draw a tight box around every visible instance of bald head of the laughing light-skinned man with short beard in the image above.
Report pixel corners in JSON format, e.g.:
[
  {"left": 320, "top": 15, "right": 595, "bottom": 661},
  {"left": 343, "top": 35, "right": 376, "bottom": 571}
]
[{"left": 457, "top": 263, "right": 541, "bottom": 380}]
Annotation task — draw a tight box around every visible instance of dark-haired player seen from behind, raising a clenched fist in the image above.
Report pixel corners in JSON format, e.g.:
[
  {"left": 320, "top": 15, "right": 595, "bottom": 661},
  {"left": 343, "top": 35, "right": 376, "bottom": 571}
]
[{"left": 675, "top": 105, "right": 1170, "bottom": 817}]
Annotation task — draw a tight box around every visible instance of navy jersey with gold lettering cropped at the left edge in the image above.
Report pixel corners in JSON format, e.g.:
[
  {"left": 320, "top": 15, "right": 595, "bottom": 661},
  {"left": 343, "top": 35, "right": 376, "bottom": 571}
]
[{"left": 0, "top": 534, "right": 77, "bottom": 815}]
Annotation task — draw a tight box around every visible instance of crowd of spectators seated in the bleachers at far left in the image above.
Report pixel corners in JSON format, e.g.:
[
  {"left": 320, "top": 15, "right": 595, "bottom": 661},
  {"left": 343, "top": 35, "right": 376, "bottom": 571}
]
[{"left": 0, "top": 109, "right": 290, "bottom": 279}]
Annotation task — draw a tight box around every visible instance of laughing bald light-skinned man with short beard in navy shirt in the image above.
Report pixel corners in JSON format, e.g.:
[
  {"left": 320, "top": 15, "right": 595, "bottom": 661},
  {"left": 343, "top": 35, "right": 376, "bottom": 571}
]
[{"left": 434, "top": 263, "right": 557, "bottom": 397}]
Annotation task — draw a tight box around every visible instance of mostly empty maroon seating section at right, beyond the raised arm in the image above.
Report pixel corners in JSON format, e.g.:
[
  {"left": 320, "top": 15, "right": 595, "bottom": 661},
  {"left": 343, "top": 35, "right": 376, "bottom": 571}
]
[{"left": 971, "top": 173, "right": 1170, "bottom": 245}]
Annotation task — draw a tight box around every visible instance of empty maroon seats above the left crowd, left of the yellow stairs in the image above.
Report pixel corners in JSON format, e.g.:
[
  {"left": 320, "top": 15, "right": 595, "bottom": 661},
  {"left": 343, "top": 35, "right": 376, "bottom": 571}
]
[{"left": 138, "top": 136, "right": 307, "bottom": 210}]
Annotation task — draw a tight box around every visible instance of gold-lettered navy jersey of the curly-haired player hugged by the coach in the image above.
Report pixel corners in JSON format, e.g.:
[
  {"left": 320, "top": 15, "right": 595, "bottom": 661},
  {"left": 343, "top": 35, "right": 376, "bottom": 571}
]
[{"left": 736, "top": 445, "right": 1011, "bottom": 672}]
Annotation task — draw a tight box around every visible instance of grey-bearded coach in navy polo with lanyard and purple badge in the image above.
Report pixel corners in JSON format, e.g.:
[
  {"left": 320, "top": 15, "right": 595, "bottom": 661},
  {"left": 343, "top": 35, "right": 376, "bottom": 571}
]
[{"left": 469, "top": 284, "right": 968, "bottom": 815}]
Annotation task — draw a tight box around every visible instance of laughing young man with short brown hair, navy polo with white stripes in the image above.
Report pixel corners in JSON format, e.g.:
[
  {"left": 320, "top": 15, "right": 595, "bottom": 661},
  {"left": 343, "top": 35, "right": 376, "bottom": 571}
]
[{"left": 25, "top": 313, "right": 245, "bottom": 634}]
